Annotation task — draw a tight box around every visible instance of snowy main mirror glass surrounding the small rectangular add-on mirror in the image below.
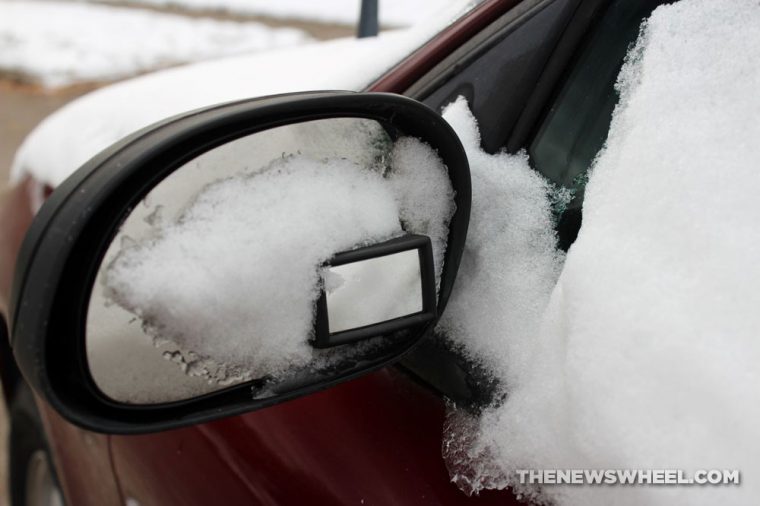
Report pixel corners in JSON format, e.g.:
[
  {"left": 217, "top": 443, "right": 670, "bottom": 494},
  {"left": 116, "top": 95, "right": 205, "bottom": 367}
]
[{"left": 93, "top": 120, "right": 454, "bottom": 402}]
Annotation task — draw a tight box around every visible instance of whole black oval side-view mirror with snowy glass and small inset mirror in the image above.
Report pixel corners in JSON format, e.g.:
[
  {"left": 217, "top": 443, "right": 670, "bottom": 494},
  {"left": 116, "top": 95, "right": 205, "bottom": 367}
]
[{"left": 11, "top": 92, "right": 470, "bottom": 433}]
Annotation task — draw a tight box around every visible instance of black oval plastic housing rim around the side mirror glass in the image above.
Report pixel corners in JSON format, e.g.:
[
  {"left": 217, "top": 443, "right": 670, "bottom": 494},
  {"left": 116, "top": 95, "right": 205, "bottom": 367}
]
[{"left": 10, "top": 91, "right": 471, "bottom": 434}]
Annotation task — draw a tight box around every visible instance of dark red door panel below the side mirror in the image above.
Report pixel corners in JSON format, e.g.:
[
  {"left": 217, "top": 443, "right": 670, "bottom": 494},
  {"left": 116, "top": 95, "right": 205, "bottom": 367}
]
[{"left": 111, "top": 368, "right": 514, "bottom": 506}]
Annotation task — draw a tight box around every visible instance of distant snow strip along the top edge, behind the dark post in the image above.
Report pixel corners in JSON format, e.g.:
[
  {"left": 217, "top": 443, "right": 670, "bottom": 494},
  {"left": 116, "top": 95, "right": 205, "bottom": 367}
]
[{"left": 94, "top": 0, "right": 456, "bottom": 26}]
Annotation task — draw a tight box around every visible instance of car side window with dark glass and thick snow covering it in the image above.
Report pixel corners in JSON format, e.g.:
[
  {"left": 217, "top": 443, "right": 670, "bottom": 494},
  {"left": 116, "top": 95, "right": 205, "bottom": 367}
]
[{"left": 441, "top": 0, "right": 760, "bottom": 505}]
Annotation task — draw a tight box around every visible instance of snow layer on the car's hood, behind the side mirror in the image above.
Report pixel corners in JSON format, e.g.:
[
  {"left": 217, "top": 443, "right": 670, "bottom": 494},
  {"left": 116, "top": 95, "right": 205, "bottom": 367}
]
[{"left": 11, "top": 0, "right": 476, "bottom": 187}]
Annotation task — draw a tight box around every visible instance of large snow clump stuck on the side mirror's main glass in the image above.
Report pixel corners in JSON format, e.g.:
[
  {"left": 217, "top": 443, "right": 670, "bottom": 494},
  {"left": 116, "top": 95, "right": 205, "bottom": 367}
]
[{"left": 105, "top": 156, "right": 402, "bottom": 377}]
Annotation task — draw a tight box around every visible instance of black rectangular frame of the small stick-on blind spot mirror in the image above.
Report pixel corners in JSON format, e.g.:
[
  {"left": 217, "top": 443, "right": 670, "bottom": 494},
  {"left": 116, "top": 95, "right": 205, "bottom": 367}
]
[{"left": 312, "top": 234, "right": 437, "bottom": 348}]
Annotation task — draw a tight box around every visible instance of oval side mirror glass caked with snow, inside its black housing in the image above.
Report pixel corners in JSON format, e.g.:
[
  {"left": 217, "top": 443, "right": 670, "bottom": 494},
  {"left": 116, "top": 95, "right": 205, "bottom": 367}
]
[{"left": 86, "top": 118, "right": 455, "bottom": 404}]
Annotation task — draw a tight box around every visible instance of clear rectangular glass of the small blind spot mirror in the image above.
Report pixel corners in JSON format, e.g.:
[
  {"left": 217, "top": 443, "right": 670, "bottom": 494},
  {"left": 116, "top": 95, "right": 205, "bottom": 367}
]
[{"left": 323, "top": 249, "right": 422, "bottom": 333}]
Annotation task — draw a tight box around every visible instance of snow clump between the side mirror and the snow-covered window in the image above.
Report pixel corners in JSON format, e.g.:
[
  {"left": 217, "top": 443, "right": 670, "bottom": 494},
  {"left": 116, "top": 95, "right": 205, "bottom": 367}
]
[{"left": 439, "top": 97, "right": 563, "bottom": 380}]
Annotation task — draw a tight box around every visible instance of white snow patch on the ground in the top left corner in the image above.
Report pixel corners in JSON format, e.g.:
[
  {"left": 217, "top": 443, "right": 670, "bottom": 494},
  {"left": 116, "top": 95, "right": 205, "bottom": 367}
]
[{"left": 0, "top": 2, "right": 308, "bottom": 87}]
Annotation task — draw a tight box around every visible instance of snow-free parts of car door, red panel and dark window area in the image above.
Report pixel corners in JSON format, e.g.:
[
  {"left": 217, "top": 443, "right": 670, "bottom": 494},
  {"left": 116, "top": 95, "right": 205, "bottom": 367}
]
[{"left": 105, "top": 0, "right": 658, "bottom": 505}]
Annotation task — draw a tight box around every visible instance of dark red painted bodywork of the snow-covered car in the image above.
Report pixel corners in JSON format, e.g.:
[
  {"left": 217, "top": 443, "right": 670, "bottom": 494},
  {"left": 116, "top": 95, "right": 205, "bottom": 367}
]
[{"left": 0, "top": 0, "right": 518, "bottom": 506}]
